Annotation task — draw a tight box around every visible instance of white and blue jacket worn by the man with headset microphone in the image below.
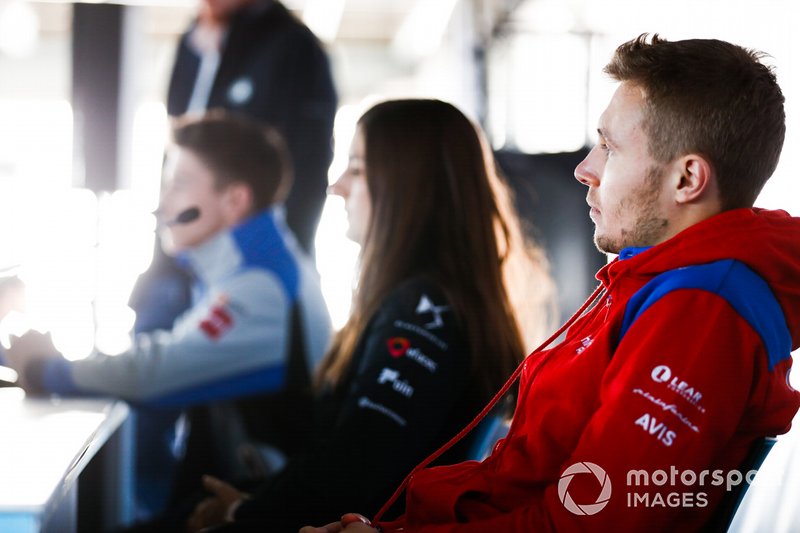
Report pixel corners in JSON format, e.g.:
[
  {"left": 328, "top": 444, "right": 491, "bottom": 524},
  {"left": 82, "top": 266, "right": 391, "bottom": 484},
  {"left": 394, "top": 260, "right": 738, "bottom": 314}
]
[{"left": 32, "top": 210, "right": 331, "bottom": 407}]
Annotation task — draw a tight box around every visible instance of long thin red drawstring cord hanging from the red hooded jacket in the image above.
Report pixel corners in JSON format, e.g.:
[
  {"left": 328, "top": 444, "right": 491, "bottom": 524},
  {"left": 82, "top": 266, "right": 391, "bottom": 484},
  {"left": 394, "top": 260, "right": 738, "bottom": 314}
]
[{"left": 372, "top": 285, "right": 603, "bottom": 527}]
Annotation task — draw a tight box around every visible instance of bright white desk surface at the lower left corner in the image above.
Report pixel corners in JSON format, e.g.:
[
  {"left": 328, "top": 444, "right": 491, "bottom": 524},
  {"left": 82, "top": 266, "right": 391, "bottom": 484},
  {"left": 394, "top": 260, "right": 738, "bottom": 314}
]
[{"left": 0, "top": 388, "right": 128, "bottom": 515}]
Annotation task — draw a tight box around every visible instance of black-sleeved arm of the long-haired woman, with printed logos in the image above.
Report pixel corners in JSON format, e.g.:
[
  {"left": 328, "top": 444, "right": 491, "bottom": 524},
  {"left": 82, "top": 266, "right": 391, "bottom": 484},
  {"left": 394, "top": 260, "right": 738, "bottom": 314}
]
[{"left": 230, "top": 280, "right": 469, "bottom": 531}]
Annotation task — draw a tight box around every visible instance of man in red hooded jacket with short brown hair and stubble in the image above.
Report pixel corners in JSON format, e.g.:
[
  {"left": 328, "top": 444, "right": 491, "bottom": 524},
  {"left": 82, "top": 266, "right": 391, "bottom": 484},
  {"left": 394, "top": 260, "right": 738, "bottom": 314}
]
[{"left": 304, "top": 35, "right": 800, "bottom": 533}]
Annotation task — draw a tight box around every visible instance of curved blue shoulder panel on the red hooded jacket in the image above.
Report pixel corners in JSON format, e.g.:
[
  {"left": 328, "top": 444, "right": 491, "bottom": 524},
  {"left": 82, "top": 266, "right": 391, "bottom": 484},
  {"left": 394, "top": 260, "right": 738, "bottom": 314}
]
[{"left": 619, "top": 259, "right": 792, "bottom": 370}]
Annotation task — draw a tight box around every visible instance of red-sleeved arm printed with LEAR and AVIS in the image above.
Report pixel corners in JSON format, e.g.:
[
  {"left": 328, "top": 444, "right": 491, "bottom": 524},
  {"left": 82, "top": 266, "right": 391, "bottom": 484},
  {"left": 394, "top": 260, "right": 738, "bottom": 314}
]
[{"left": 382, "top": 290, "right": 797, "bottom": 533}]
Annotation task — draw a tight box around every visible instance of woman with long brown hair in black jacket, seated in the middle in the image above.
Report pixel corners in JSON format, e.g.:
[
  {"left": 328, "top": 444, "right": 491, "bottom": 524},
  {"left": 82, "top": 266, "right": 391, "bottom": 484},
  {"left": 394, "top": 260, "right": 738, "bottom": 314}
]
[{"left": 171, "top": 100, "right": 552, "bottom": 532}]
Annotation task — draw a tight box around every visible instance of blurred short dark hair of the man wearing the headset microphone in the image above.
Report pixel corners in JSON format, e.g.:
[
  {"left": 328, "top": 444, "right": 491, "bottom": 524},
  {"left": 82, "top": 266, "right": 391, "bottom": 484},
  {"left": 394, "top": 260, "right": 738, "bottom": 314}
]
[{"left": 172, "top": 110, "right": 292, "bottom": 212}]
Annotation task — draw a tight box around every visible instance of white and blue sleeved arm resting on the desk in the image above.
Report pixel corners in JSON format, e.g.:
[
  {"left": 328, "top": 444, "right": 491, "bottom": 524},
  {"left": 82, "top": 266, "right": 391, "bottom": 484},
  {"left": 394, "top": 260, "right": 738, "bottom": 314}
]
[{"left": 14, "top": 270, "right": 289, "bottom": 406}]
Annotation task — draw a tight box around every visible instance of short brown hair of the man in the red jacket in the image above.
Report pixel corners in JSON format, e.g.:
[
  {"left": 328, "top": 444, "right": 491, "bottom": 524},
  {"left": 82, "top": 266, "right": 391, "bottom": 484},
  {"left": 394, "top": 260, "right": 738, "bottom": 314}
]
[{"left": 605, "top": 34, "right": 786, "bottom": 209}]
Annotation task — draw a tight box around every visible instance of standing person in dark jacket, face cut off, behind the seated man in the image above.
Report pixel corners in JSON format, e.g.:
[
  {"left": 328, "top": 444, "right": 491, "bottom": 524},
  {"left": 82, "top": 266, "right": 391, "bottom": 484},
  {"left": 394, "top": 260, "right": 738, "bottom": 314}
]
[{"left": 167, "top": 0, "right": 337, "bottom": 253}]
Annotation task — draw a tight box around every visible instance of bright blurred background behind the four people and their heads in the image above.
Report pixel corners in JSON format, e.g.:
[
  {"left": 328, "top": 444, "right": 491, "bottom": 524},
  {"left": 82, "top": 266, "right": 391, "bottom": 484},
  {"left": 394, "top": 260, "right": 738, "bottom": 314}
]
[{"left": 0, "top": 0, "right": 800, "bottom": 530}]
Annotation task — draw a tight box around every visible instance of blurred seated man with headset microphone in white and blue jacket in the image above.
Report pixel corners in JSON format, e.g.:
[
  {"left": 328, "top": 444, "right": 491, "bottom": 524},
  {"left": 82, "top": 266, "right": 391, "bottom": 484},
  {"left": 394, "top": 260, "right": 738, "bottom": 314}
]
[{"left": 7, "top": 113, "right": 330, "bottom": 516}]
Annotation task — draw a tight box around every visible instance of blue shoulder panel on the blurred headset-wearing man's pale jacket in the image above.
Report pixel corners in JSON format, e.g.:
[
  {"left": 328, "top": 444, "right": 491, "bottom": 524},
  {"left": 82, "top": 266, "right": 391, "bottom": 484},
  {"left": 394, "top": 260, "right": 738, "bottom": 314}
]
[{"left": 238, "top": 210, "right": 300, "bottom": 303}]
